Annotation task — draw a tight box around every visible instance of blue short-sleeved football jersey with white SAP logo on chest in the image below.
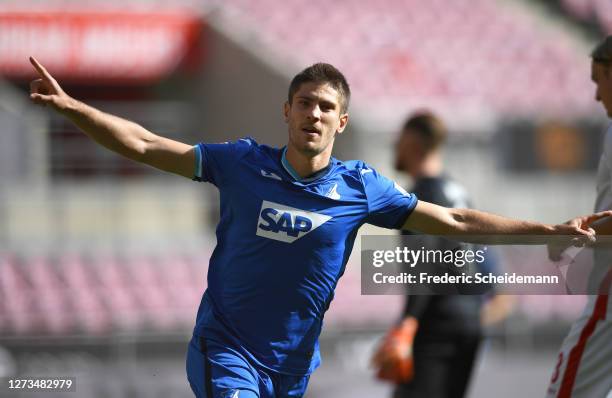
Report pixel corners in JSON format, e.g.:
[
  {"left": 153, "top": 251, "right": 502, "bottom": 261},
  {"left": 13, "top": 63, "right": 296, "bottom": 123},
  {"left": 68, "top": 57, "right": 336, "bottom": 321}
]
[{"left": 194, "top": 138, "right": 417, "bottom": 375}]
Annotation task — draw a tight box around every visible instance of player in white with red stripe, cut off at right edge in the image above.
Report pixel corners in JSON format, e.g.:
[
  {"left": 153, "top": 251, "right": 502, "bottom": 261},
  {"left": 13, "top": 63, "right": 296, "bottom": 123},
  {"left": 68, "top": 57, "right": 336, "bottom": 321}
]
[{"left": 547, "top": 36, "right": 612, "bottom": 398}]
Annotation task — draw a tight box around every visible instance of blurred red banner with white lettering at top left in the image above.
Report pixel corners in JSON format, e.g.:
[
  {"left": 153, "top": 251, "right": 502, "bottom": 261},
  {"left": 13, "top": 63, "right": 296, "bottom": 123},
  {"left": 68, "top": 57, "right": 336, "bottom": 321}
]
[{"left": 0, "top": 12, "right": 202, "bottom": 83}]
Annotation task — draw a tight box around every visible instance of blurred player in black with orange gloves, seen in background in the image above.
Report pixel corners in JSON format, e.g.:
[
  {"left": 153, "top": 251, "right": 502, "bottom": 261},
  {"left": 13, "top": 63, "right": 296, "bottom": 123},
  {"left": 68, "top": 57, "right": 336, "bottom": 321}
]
[{"left": 374, "top": 112, "right": 511, "bottom": 398}]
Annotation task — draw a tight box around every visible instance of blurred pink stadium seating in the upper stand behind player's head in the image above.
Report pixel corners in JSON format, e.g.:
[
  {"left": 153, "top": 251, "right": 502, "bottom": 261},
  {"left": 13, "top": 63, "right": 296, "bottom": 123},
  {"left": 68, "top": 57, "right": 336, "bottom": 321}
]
[{"left": 209, "top": 0, "right": 592, "bottom": 123}]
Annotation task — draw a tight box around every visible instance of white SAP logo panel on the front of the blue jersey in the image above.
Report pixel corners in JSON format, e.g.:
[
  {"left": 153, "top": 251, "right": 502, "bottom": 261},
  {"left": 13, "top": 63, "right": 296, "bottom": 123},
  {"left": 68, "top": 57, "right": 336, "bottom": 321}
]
[{"left": 257, "top": 200, "right": 331, "bottom": 243}]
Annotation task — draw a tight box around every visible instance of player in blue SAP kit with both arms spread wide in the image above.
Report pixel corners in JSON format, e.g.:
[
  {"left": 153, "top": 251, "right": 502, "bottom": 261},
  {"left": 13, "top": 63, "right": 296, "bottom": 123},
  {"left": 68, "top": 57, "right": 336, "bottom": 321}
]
[{"left": 30, "top": 59, "right": 612, "bottom": 398}]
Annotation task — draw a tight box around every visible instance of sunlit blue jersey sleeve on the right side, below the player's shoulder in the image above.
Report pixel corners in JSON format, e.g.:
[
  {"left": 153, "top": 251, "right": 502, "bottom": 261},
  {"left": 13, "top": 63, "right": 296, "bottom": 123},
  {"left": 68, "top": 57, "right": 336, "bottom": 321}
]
[{"left": 361, "top": 167, "right": 417, "bottom": 229}]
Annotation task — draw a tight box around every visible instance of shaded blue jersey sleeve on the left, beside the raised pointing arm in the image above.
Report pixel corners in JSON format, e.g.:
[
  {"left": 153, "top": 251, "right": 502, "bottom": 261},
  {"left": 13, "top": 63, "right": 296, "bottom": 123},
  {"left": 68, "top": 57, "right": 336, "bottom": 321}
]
[{"left": 193, "top": 138, "right": 257, "bottom": 186}]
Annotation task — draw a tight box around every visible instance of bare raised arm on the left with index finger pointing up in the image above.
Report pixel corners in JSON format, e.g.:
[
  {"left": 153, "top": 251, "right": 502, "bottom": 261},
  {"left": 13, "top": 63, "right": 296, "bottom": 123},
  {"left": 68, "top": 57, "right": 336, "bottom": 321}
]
[{"left": 30, "top": 57, "right": 195, "bottom": 178}]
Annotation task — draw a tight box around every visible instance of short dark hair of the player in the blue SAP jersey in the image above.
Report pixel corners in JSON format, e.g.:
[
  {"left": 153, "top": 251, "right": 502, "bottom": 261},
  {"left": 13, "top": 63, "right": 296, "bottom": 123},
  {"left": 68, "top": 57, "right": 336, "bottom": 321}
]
[{"left": 289, "top": 62, "right": 351, "bottom": 113}]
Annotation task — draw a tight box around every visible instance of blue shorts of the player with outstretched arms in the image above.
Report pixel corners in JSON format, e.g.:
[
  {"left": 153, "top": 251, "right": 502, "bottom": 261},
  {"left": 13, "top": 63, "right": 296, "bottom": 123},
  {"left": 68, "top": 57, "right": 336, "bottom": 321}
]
[{"left": 187, "top": 335, "right": 310, "bottom": 398}]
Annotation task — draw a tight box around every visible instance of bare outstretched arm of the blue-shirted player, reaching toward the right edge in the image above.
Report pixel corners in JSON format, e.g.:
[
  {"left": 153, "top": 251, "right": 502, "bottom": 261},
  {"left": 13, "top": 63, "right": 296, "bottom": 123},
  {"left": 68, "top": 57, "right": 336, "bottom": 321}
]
[{"left": 402, "top": 201, "right": 612, "bottom": 243}]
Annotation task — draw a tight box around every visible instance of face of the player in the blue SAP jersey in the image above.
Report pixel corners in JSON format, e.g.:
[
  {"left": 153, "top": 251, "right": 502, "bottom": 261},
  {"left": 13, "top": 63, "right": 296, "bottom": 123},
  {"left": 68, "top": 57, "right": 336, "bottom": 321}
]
[{"left": 284, "top": 82, "right": 348, "bottom": 157}]
